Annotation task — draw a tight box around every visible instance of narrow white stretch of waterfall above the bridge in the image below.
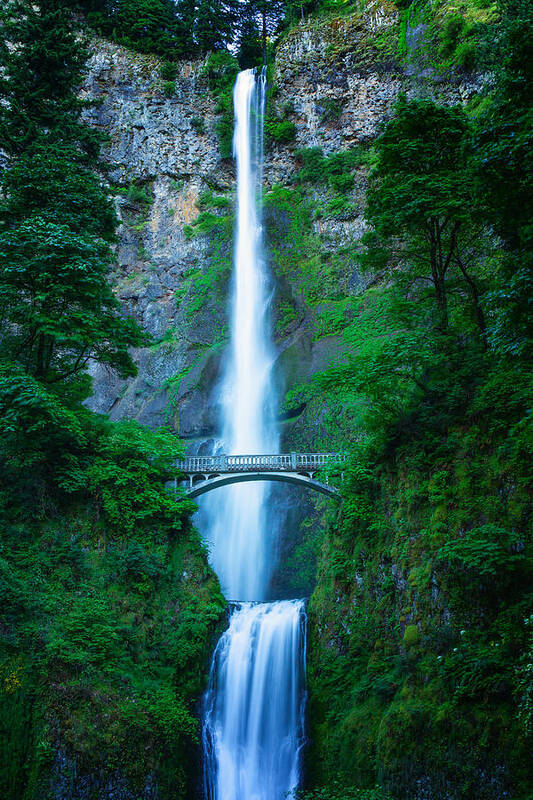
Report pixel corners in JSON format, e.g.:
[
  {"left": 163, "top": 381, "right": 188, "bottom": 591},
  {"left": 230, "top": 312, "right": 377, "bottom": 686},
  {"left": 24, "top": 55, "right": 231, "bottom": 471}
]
[{"left": 224, "top": 69, "right": 279, "bottom": 456}]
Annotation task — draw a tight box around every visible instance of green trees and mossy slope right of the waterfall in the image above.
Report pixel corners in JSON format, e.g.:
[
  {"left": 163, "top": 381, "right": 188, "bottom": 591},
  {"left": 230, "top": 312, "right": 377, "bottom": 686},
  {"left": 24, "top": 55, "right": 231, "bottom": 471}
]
[{"left": 296, "top": 2, "right": 533, "bottom": 800}]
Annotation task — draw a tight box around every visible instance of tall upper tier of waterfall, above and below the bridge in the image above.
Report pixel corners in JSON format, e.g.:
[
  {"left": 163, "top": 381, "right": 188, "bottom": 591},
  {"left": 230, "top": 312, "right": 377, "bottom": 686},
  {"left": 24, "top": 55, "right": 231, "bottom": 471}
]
[{"left": 196, "top": 69, "right": 279, "bottom": 601}]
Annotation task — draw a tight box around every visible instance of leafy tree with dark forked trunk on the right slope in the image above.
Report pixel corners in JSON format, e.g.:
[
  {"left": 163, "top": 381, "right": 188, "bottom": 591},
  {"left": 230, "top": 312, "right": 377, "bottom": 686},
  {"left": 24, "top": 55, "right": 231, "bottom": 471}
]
[{"left": 362, "top": 98, "right": 486, "bottom": 346}]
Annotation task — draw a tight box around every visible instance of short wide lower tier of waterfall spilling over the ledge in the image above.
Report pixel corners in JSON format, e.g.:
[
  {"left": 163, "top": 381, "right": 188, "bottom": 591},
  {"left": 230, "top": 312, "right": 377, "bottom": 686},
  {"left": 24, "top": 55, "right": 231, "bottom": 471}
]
[{"left": 203, "top": 600, "right": 305, "bottom": 800}]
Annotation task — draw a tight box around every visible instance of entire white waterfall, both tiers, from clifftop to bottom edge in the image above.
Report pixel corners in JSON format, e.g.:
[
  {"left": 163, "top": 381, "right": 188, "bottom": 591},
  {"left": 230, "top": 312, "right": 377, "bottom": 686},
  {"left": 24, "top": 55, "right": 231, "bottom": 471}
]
[{"left": 201, "top": 70, "right": 306, "bottom": 800}]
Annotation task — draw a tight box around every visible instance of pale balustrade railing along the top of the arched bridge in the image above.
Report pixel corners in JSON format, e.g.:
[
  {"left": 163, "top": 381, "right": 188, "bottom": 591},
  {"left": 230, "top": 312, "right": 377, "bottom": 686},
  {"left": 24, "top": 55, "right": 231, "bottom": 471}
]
[{"left": 176, "top": 453, "right": 346, "bottom": 474}]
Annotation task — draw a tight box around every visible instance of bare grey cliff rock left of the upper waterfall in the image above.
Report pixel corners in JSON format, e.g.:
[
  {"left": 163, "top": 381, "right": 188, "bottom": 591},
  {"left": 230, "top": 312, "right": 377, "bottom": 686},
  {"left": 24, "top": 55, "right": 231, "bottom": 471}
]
[{"left": 81, "top": 40, "right": 232, "bottom": 436}]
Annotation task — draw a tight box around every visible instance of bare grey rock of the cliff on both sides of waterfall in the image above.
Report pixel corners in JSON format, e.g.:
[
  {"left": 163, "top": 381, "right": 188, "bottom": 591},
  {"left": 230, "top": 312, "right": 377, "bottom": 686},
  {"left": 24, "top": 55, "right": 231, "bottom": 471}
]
[{"left": 84, "top": 9, "right": 479, "bottom": 446}]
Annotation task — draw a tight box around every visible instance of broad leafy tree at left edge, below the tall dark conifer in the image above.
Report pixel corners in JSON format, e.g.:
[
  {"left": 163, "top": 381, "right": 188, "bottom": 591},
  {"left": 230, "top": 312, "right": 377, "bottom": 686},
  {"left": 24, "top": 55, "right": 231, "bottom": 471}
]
[{"left": 0, "top": 216, "right": 142, "bottom": 383}]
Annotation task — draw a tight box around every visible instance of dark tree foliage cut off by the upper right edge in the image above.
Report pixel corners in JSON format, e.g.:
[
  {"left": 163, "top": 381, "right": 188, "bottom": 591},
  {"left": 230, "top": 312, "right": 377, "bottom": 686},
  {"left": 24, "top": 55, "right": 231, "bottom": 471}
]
[{"left": 475, "top": 0, "right": 533, "bottom": 358}]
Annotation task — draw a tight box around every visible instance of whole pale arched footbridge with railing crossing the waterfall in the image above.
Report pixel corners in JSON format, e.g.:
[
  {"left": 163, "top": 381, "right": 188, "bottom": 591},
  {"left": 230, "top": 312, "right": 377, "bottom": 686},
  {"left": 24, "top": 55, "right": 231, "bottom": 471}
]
[{"left": 176, "top": 453, "right": 346, "bottom": 497}]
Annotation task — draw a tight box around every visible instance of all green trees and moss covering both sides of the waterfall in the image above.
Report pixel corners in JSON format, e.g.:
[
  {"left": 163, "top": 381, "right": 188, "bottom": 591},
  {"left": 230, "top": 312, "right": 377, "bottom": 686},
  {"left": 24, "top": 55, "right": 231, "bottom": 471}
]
[{"left": 0, "top": 0, "right": 533, "bottom": 800}]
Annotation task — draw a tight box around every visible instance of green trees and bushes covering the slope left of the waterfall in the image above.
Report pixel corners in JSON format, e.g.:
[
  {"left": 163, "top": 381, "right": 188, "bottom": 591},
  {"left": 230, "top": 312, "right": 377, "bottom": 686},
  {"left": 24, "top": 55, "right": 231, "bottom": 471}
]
[{"left": 0, "top": 0, "right": 224, "bottom": 800}]
